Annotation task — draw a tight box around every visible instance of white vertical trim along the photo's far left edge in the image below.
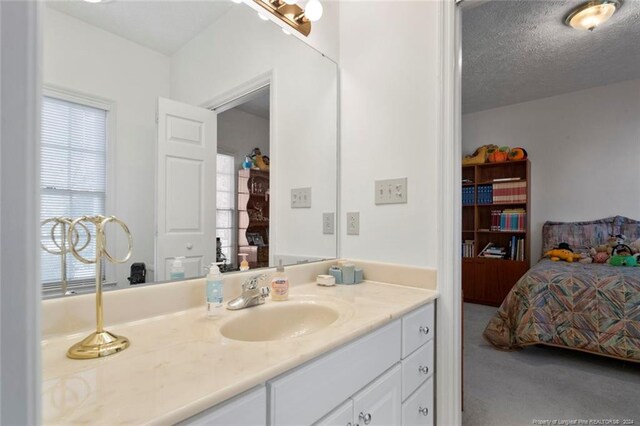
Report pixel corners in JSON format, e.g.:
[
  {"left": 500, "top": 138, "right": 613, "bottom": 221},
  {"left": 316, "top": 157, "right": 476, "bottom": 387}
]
[{"left": 0, "top": 0, "right": 41, "bottom": 425}]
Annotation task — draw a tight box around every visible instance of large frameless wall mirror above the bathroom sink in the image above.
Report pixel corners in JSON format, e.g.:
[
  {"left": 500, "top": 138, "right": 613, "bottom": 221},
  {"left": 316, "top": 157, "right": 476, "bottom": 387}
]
[{"left": 41, "top": 1, "right": 338, "bottom": 295}]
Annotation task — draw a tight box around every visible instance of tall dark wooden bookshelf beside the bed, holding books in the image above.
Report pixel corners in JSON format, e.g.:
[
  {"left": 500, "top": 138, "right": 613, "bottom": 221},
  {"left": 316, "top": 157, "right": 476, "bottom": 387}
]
[{"left": 462, "top": 160, "right": 531, "bottom": 306}]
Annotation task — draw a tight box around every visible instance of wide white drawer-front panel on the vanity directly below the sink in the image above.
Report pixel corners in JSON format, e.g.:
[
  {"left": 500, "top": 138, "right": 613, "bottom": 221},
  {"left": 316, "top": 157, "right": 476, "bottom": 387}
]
[{"left": 268, "top": 320, "right": 402, "bottom": 426}]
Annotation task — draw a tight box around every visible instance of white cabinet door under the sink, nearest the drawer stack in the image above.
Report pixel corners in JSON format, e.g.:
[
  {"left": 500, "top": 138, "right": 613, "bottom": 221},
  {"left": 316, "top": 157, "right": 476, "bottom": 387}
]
[{"left": 353, "top": 364, "right": 402, "bottom": 426}]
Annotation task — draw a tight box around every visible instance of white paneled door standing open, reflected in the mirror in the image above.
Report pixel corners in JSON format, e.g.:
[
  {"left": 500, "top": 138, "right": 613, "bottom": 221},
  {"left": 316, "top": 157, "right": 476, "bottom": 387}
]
[{"left": 155, "top": 98, "right": 218, "bottom": 280}]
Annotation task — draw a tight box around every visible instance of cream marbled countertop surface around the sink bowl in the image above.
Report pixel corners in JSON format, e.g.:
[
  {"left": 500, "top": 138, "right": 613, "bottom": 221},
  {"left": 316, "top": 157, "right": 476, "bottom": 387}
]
[{"left": 42, "top": 281, "right": 437, "bottom": 424}]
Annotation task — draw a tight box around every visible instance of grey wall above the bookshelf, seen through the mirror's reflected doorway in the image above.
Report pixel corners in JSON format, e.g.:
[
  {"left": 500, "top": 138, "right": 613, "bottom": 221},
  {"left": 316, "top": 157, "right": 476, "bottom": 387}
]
[{"left": 218, "top": 108, "right": 269, "bottom": 171}]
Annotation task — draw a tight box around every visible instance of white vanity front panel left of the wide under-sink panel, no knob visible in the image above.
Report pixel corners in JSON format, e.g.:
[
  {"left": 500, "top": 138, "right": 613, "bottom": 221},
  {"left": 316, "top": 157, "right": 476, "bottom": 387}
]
[{"left": 179, "top": 386, "right": 267, "bottom": 426}]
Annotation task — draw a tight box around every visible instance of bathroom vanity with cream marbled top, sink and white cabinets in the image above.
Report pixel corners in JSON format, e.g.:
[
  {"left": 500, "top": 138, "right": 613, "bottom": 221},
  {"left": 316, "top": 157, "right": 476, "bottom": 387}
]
[{"left": 43, "top": 262, "right": 437, "bottom": 425}]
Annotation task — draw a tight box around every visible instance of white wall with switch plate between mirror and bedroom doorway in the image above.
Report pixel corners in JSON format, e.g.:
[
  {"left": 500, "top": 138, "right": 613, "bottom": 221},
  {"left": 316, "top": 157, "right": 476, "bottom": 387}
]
[{"left": 340, "top": 1, "right": 441, "bottom": 267}]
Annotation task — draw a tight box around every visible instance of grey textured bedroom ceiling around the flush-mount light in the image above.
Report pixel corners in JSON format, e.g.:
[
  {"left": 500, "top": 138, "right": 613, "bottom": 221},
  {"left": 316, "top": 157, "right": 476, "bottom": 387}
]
[{"left": 462, "top": 0, "right": 640, "bottom": 113}]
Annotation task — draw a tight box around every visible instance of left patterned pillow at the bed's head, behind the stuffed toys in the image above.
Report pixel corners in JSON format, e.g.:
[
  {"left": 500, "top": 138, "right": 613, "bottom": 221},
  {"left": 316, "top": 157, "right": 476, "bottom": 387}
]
[{"left": 542, "top": 217, "right": 616, "bottom": 256}]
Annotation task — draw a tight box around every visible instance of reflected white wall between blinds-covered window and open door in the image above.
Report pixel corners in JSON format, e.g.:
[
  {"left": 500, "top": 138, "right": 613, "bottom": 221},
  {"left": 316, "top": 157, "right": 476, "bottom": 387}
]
[{"left": 42, "top": 7, "right": 170, "bottom": 287}]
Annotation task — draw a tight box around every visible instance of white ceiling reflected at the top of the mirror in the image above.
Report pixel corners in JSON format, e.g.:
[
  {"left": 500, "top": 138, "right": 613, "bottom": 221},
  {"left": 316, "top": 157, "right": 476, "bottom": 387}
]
[{"left": 47, "top": 0, "right": 233, "bottom": 55}]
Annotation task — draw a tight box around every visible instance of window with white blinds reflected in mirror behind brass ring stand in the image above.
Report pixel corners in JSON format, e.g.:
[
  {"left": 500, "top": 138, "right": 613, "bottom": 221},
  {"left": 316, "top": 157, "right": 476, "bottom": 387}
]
[{"left": 40, "top": 96, "right": 107, "bottom": 286}]
